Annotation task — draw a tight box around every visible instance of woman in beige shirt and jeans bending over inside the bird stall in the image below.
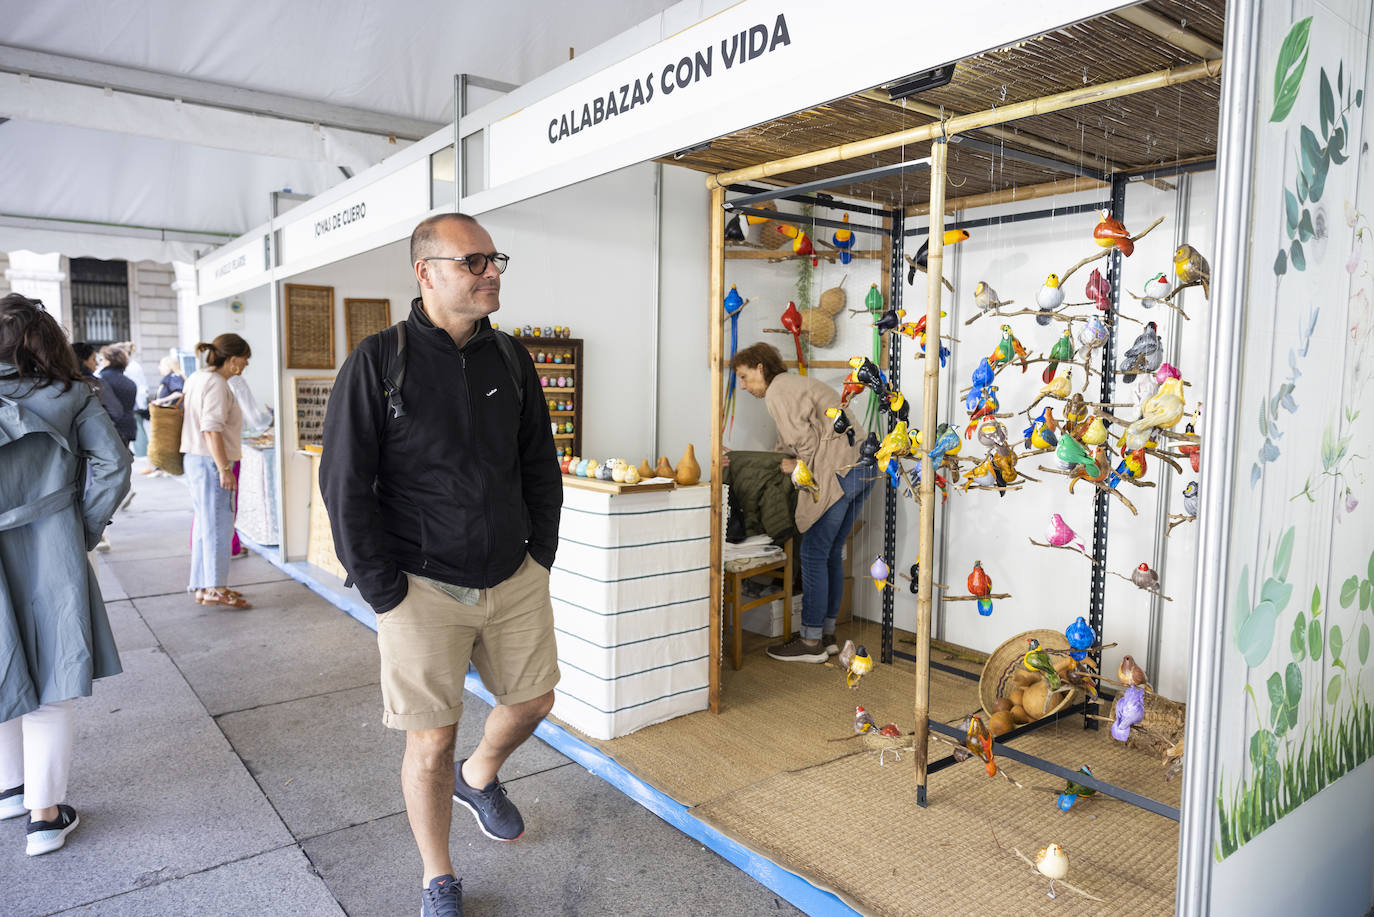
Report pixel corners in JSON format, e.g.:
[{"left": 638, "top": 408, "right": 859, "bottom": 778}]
[{"left": 730, "top": 342, "right": 877, "bottom": 663}]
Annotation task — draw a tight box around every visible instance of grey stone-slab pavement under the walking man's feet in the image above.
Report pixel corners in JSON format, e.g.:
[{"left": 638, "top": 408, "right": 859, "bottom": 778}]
[{"left": 8, "top": 462, "right": 802, "bottom": 917}]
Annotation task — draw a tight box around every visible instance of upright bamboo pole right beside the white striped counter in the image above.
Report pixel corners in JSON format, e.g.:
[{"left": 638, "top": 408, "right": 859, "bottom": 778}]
[{"left": 706, "top": 188, "right": 725, "bottom": 714}]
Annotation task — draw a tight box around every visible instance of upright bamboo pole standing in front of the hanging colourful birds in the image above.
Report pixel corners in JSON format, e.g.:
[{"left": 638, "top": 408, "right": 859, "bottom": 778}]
[{"left": 912, "top": 140, "right": 949, "bottom": 806}]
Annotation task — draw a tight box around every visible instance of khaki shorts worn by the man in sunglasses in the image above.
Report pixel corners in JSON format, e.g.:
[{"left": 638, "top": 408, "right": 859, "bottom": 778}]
[{"left": 376, "top": 554, "right": 559, "bottom": 730}]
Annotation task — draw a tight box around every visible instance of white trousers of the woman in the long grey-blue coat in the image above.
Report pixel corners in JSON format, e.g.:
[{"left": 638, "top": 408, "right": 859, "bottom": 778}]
[{"left": 0, "top": 701, "right": 74, "bottom": 811}]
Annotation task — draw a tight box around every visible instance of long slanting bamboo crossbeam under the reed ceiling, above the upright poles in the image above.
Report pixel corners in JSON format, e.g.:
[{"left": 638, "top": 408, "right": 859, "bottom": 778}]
[{"left": 706, "top": 60, "right": 1221, "bottom": 191}]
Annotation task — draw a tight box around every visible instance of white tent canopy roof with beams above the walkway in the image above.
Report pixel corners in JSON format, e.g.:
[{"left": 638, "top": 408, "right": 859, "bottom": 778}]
[{"left": 0, "top": 0, "right": 681, "bottom": 261}]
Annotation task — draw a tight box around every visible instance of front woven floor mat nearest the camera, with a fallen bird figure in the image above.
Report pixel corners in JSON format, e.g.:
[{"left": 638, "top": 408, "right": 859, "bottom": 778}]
[{"left": 692, "top": 720, "right": 1180, "bottom": 917}]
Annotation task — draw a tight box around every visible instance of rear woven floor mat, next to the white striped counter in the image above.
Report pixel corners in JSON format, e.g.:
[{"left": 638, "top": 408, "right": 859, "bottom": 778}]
[{"left": 573, "top": 626, "right": 978, "bottom": 806}]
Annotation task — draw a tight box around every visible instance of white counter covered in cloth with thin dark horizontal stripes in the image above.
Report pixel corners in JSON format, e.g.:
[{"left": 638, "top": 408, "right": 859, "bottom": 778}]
[{"left": 550, "top": 478, "right": 710, "bottom": 740}]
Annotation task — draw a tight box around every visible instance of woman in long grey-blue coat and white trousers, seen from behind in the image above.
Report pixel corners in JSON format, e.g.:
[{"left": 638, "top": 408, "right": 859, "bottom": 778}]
[{"left": 0, "top": 293, "right": 132, "bottom": 857}]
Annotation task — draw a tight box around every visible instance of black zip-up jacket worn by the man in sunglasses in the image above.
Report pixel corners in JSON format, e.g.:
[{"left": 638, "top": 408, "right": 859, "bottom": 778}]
[{"left": 320, "top": 300, "right": 563, "bottom": 613}]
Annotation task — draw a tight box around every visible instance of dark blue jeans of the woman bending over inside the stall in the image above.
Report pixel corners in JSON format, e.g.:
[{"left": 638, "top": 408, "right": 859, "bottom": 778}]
[{"left": 801, "top": 466, "right": 875, "bottom": 641}]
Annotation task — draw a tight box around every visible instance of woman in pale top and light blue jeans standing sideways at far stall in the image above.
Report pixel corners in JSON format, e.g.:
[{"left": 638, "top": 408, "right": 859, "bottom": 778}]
[{"left": 181, "top": 334, "right": 253, "bottom": 608}]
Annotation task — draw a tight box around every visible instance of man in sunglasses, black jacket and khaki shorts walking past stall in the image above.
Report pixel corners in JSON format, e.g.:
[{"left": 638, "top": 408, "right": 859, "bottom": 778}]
[{"left": 320, "top": 213, "right": 563, "bottom": 917}]
